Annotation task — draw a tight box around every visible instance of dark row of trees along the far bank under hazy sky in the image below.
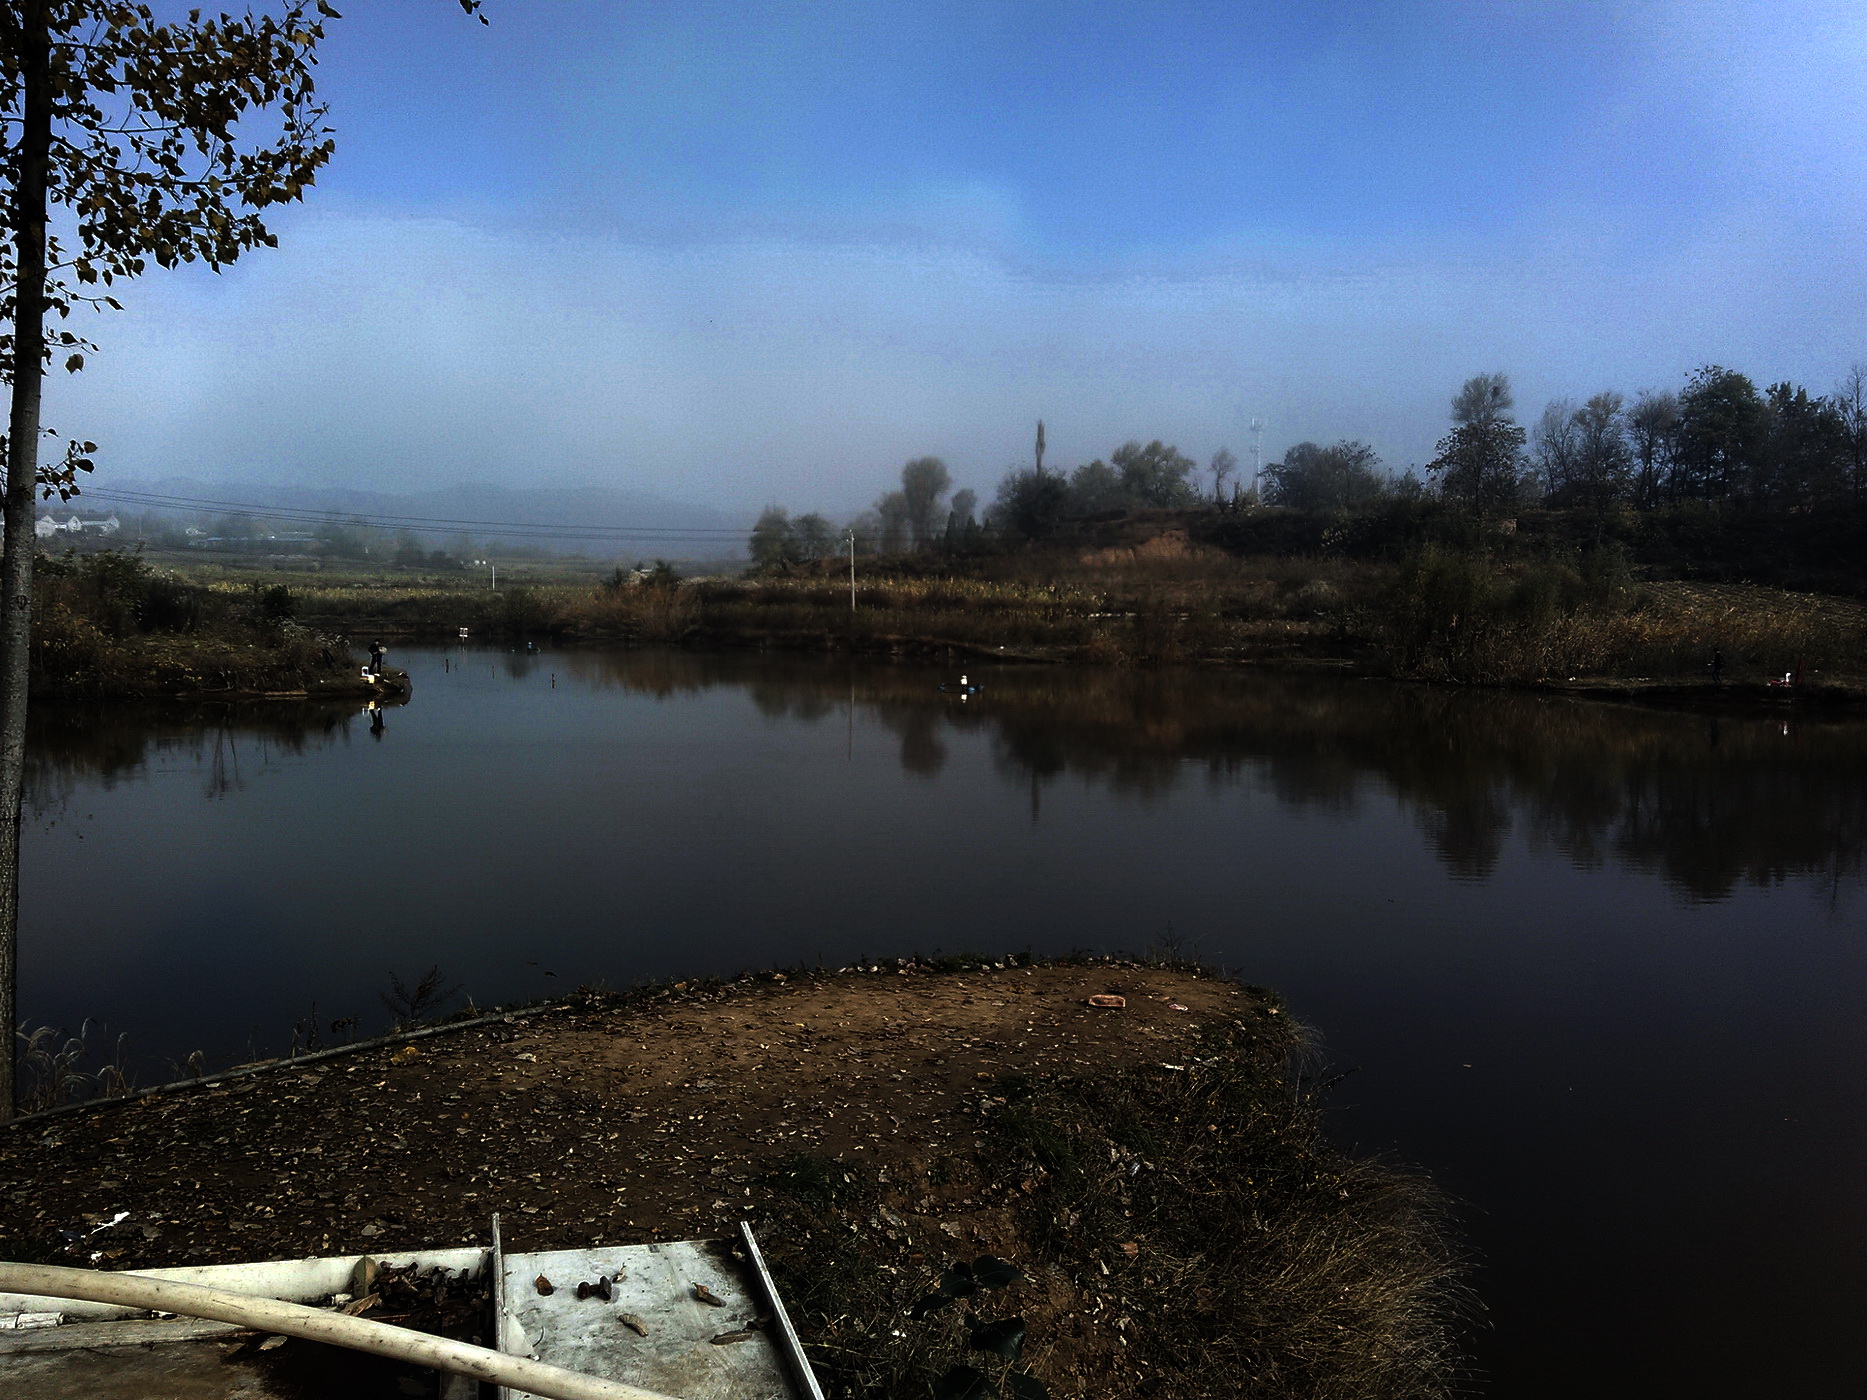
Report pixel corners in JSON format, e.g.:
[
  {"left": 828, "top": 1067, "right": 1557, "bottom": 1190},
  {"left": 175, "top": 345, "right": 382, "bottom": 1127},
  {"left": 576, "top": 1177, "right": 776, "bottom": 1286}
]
[{"left": 751, "top": 364, "right": 1867, "bottom": 582}]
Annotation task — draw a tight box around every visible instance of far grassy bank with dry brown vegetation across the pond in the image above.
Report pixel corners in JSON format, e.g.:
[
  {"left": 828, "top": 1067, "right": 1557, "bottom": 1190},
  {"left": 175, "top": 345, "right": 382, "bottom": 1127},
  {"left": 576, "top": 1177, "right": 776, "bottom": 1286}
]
[{"left": 252, "top": 530, "right": 1867, "bottom": 694}]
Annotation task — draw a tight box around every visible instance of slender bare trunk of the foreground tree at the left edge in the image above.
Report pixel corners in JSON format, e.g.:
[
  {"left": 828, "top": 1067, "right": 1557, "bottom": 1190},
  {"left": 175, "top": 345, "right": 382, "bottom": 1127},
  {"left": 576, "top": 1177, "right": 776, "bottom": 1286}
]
[{"left": 0, "top": 0, "right": 52, "bottom": 1122}]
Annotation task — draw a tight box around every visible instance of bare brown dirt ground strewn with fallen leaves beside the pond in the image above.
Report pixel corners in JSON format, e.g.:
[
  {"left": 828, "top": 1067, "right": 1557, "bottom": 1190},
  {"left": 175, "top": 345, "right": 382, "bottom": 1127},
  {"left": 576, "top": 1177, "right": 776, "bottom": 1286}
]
[{"left": 0, "top": 963, "right": 1256, "bottom": 1267}]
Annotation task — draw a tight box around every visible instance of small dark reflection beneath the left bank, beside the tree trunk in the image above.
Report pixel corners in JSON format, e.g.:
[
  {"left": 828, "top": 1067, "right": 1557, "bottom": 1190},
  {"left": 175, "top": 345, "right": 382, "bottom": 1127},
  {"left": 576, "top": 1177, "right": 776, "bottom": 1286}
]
[{"left": 26, "top": 704, "right": 362, "bottom": 816}]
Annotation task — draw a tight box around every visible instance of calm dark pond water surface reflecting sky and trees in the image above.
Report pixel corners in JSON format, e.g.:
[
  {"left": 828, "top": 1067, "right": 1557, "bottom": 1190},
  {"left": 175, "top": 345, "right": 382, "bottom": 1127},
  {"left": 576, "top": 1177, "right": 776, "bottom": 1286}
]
[{"left": 22, "top": 650, "right": 1867, "bottom": 1398}]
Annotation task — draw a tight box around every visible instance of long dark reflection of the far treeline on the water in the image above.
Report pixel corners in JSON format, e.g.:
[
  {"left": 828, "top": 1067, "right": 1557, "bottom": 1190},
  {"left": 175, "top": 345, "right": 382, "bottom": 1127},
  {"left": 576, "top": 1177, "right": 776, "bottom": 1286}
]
[{"left": 573, "top": 651, "right": 1867, "bottom": 900}]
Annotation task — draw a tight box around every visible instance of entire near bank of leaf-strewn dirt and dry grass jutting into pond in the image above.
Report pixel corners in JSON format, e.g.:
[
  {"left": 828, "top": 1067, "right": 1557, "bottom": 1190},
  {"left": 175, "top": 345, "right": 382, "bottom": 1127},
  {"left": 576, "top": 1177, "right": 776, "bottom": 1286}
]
[{"left": 0, "top": 958, "right": 1462, "bottom": 1400}]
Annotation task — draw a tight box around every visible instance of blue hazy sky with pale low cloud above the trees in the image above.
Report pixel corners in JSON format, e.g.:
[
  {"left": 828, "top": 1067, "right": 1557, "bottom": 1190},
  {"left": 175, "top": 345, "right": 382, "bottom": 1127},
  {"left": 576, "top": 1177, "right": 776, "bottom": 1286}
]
[{"left": 40, "top": 0, "right": 1867, "bottom": 513}]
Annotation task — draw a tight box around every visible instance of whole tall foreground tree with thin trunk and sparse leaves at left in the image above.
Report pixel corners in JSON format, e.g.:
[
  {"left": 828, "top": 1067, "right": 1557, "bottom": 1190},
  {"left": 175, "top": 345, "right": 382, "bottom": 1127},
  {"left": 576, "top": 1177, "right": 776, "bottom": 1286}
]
[{"left": 0, "top": 0, "right": 352, "bottom": 1116}]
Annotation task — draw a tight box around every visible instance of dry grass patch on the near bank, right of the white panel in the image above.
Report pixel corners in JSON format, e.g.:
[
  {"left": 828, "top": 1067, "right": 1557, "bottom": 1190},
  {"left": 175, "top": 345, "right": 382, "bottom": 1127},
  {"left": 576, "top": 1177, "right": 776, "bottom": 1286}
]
[{"left": 767, "top": 1010, "right": 1469, "bottom": 1400}]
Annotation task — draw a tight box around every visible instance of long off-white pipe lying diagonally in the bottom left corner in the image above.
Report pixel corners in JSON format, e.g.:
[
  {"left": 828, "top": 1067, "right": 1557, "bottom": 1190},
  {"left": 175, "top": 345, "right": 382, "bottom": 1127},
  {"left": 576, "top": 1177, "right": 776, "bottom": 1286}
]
[{"left": 0, "top": 1262, "right": 687, "bottom": 1400}]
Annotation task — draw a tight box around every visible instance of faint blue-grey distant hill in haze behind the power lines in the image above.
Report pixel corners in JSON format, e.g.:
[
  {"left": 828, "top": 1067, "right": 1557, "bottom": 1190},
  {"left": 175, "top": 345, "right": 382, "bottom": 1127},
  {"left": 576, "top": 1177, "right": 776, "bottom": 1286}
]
[{"left": 82, "top": 476, "right": 752, "bottom": 558}]
